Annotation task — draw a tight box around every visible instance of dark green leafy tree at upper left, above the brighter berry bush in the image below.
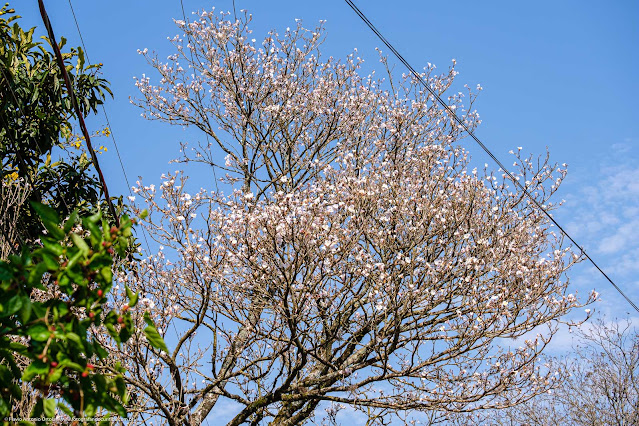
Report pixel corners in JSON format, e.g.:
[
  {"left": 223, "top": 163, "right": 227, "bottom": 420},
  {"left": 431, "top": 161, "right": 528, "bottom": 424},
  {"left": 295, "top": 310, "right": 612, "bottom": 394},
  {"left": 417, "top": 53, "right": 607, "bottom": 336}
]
[{"left": 0, "top": 5, "right": 111, "bottom": 243}]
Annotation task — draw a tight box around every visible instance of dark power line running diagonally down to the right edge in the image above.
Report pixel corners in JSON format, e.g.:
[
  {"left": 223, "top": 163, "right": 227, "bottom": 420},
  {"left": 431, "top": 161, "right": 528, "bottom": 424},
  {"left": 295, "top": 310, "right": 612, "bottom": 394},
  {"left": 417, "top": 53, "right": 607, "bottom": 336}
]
[{"left": 345, "top": 0, "right": 639, "bottom": 312}]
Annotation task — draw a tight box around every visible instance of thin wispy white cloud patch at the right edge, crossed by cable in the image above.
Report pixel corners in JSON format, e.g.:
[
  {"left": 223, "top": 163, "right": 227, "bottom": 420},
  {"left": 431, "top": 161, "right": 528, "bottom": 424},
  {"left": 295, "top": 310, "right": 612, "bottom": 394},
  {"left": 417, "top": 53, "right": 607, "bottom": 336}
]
[{"left": 557, "top": 139, "right": 639, "bottom": 316}]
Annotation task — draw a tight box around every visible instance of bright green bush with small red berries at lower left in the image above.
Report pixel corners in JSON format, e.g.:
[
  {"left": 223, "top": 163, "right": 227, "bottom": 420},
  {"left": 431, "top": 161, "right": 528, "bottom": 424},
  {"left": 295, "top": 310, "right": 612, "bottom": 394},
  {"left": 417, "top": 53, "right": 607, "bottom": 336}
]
[{"left": 0, "top": 203, "right": 162, "bottom": 423}]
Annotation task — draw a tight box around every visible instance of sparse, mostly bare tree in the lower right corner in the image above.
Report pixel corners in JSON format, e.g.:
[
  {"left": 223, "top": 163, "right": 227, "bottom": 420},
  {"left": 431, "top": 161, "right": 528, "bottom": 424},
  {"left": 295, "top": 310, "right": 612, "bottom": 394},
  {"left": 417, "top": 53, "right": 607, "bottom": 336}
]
[{"left": 456, "top": 318, "right": 639, "bottom": 426}]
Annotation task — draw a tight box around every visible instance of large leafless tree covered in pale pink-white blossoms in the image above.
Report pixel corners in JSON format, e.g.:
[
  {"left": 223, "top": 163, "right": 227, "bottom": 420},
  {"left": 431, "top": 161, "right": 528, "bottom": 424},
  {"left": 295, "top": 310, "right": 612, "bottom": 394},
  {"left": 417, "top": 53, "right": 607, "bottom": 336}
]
[{"left": 124, "top": 8, "right": 595, "bottom": 425}]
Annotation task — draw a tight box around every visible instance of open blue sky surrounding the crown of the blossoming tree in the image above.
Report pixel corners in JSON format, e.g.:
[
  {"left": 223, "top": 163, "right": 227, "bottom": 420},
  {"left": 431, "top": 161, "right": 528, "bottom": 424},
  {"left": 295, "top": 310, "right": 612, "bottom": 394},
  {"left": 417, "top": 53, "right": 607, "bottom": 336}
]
[{"left": 11, "top": 0, "right": 639, "bottom": 422}]
